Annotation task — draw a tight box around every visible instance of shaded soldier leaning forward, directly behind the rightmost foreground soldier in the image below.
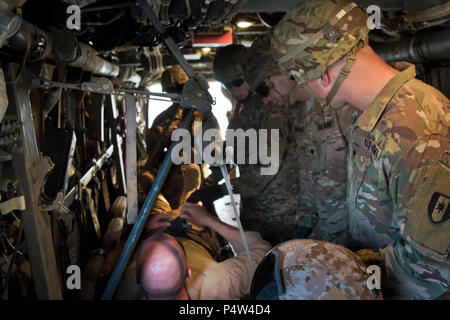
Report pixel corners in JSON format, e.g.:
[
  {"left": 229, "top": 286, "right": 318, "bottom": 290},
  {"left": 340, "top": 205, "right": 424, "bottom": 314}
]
[{"left": 244, "top": 35, "right": 357, "bottom": 245}]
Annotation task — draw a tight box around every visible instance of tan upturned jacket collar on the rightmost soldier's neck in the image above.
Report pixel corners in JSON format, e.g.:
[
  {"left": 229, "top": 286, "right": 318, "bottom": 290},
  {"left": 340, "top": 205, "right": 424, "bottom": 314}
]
[{"left": 355, "top": 65, "right": 416, "bottom": 132}]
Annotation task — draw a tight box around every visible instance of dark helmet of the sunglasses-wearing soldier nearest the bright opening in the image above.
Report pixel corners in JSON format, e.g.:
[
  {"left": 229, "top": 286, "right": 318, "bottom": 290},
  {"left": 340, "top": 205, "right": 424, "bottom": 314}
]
[{"left": 213, "top": 44, "right": 247, "bottom": 84}]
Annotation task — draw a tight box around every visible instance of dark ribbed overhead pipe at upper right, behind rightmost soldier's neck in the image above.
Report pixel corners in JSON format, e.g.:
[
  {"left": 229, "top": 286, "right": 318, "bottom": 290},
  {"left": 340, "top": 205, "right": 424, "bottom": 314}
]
[{"left": 370, "top": 28, "right": 450, "bottom": 62}]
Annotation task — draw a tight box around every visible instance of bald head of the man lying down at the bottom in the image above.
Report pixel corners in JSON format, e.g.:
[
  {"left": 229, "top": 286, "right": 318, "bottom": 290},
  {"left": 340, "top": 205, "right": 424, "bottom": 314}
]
[{"left": 136, "top": 233, "right": 187, "bottom": 299}]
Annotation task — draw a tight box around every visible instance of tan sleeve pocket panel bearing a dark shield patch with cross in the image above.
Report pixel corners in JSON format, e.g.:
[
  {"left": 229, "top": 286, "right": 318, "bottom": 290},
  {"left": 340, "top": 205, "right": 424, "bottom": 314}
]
[{"left": 404, "top": 162, "right": 450, "bottom": 255}]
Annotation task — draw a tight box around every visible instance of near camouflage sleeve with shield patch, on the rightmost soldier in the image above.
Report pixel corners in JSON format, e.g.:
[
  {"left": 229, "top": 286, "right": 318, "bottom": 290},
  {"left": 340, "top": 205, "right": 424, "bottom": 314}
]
[{"left": 383, "top": 135, "right": 450, "bottom": 299}]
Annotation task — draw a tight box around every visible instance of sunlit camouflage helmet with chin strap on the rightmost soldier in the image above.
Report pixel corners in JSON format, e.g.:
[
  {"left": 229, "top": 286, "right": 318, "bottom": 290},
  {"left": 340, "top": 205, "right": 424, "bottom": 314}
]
[{"left": 272, "top": 0, "right": 369, "bottom": 103}]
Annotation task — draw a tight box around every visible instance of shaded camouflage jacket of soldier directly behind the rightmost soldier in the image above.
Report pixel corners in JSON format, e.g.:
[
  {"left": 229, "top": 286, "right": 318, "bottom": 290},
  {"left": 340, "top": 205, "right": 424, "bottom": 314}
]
[{"left": 295, "top": 101, "right": 359, "bottom": 246}]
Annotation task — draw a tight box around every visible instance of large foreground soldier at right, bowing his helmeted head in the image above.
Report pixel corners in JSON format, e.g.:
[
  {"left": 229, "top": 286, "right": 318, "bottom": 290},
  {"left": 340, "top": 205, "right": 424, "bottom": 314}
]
[{"left": 273, "top": 0, "right": 450, "bottom": 299}]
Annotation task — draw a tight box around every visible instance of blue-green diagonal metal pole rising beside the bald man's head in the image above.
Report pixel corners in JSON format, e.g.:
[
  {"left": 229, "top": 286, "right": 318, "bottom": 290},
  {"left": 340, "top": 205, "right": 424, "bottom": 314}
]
[{"left": 101, "top": 109, "right": 194, "bottom": 300}]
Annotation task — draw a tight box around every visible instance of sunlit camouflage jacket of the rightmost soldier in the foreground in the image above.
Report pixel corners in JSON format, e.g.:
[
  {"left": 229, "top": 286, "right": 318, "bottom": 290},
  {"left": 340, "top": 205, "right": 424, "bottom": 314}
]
[{"left": 348, "top": 67, "right": 450, "bottom": 299}]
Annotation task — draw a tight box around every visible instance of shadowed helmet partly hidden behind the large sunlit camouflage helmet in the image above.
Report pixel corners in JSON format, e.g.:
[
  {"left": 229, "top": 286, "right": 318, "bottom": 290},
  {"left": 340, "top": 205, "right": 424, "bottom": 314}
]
[{"left": 243, "top": 34, "right": 281, "bottom": 92}]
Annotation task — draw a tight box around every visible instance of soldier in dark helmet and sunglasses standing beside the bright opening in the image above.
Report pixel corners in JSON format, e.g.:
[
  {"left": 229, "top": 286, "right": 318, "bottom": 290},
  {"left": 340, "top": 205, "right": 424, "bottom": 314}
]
[{"left": 210, "top": 46, "right": 299, "bottom": 244}]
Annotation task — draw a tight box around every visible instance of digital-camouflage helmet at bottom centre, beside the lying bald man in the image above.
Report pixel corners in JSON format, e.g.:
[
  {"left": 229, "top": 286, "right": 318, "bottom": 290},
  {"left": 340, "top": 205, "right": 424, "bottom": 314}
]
[{"left": 250, "top": 239, "right": 380, "bottom": 300}]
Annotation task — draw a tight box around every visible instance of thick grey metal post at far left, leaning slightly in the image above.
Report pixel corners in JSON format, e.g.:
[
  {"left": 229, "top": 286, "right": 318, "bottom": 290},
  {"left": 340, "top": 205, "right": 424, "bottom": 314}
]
[{"left": 8, "top": 64, "right": 62, "bottom": 300}]
